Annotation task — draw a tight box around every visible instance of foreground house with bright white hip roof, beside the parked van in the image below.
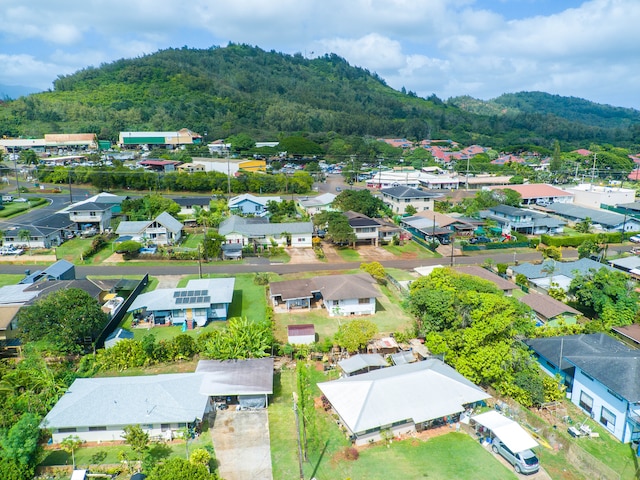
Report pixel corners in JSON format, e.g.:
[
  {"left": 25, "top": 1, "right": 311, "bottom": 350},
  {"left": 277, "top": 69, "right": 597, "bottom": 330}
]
[{"left": 318, "top": 358, "right": 491, "bottom": 445}]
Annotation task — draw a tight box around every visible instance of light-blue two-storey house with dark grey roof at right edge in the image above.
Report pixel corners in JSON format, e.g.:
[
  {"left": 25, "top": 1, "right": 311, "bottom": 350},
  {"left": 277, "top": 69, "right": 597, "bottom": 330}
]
[{"left": 524, "top": 333, "right": 640, "bottom": 443}]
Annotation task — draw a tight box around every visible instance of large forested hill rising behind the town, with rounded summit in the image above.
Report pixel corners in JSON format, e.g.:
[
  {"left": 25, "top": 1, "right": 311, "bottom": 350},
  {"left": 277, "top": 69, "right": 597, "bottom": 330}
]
[{"left": 0, "top": 44, "right": 640, "bottom": 148}]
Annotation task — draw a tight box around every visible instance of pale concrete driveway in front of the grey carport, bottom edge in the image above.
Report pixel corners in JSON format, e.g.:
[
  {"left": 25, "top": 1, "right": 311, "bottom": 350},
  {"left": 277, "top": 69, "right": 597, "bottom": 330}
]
[{"left": 211, "top": 409, "right": 273, "bottom": 480}]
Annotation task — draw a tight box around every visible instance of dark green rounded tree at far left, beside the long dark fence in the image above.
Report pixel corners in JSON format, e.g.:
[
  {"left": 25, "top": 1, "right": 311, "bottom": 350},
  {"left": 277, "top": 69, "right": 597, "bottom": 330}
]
[{"left": 18, "top": 288, "right": 107, "bottom": 353}]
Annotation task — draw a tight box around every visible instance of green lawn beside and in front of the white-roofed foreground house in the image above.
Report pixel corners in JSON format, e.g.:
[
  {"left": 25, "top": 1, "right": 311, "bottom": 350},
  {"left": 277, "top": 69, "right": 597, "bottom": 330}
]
[{"left": 269, "top": 370, "right": 515, "bottom": 480}]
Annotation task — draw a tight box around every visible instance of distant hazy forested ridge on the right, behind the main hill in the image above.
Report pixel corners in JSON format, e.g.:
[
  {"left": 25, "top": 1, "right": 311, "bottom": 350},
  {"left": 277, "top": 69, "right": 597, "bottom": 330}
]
[{"left": 448, "top": 92, "right": 640, "bottom": 129}]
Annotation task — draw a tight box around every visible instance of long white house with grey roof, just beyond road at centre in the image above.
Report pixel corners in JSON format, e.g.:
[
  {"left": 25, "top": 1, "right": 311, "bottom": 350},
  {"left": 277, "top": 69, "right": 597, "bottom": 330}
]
[{"left": 218, "top": 215, "right": 313, "bottom": 248}]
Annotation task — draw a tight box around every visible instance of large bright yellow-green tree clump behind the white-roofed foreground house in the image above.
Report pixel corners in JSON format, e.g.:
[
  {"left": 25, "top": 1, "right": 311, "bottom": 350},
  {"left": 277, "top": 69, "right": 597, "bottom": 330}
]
[{"left": 409, "top": 268, "right": 545, "bottom": 406}]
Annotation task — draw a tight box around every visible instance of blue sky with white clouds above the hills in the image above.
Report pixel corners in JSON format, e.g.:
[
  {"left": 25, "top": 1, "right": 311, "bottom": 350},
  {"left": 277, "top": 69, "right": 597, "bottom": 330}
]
[{"left": 0, "top": 0, "right": 640, "bottom": 109}]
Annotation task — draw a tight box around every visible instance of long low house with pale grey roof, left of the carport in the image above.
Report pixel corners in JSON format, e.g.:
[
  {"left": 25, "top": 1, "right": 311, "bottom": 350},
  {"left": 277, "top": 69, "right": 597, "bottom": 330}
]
[{"left": 40, "top": 373, "right": 211, "bottom": 444}]
